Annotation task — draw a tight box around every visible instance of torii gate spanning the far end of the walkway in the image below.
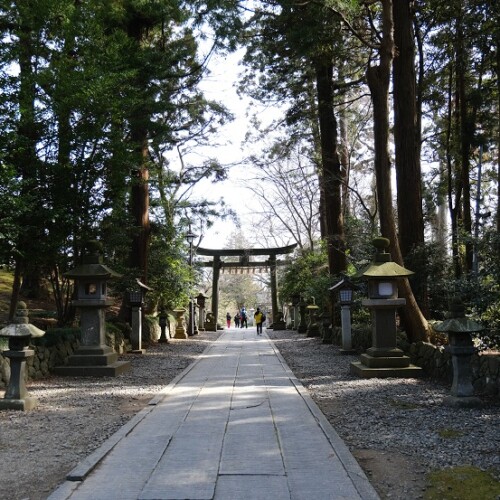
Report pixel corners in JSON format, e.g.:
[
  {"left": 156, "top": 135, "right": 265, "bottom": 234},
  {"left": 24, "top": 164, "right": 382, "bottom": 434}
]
[{"left": 196, "top": 243, "right": 297, "bottom": 325}]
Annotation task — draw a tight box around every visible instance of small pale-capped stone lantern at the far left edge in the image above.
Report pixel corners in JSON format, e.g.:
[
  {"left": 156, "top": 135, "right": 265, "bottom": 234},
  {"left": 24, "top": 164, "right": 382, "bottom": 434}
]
[{"left": 0, "top": 302, "right": 45, "bottom": 411}]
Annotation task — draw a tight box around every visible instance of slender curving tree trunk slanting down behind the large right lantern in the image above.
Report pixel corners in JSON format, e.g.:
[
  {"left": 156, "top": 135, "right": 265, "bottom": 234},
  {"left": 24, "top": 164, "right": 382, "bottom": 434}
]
[{"left": 366, "top": 0, "right": 428, "bottom": 342}]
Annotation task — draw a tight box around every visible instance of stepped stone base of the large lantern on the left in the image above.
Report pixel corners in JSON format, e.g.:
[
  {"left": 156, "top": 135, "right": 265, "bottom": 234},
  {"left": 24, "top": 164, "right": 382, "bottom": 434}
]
[{"left": 54, "top": 346, "right": 131, "bottom": 377}]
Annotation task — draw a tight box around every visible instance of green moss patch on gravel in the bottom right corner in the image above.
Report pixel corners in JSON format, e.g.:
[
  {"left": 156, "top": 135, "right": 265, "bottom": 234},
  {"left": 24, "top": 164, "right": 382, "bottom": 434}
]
[{"left": 424, "top": 466, "right": 500, "bottom": 500}]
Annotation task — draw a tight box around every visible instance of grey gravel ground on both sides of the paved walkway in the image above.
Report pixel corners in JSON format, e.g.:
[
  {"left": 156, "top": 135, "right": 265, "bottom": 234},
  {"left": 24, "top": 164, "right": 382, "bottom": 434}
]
[{"left": 0, "top": 330, "right": 500, "bottom": 500}]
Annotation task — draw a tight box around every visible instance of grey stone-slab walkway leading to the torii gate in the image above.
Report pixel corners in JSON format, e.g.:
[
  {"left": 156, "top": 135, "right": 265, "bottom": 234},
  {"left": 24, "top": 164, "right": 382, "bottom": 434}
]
[{"left": 49, "top": 328, "right": 378, "bottom": 500}]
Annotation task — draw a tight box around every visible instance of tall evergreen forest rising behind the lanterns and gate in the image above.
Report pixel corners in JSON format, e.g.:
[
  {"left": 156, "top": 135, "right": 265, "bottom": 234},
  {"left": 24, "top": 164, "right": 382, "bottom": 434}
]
[{"left": 0, "top": 0, "right": 500, "bottom": 348}]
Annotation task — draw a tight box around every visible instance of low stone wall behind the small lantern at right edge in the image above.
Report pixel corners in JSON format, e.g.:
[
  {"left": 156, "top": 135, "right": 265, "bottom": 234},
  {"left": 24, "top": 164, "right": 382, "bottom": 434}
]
[{"left": 408, "top": 342, "right": 500, "bottom": 395}]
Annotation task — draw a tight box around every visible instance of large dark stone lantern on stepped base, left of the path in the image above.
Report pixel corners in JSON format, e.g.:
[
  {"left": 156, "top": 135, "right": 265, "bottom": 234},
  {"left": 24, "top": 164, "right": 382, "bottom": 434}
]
[{"left": 54, "top": 242, "right": 130, "bottom": 377}]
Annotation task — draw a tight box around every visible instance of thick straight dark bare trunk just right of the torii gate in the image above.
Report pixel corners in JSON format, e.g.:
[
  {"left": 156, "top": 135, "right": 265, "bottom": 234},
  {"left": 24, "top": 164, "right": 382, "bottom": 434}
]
[{"left": 315, "top": 57, "right": 346, "bottom": 275}]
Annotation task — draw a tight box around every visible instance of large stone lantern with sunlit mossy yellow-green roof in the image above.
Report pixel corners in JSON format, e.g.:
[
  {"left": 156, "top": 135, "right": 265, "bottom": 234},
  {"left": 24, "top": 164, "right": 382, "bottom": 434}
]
[{"left": 351, "top": 238, "right": 422, "bottom": 378}]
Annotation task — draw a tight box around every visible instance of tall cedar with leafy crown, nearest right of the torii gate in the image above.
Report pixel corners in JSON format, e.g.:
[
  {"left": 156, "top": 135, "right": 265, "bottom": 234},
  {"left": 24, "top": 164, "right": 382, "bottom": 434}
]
[{"left": 245, "top": 1, "right": 346, "bottom": 274}]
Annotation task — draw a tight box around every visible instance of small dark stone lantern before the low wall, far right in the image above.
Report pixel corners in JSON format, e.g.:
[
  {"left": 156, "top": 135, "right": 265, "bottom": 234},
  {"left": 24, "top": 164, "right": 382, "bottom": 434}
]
[{"left": 434, "top": 297, "right": 484, "bottom": 407}]
